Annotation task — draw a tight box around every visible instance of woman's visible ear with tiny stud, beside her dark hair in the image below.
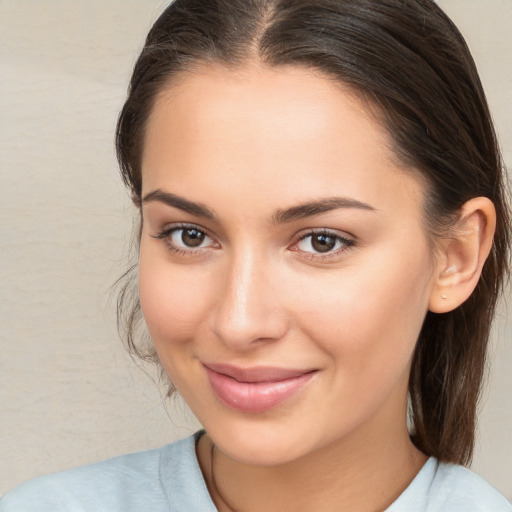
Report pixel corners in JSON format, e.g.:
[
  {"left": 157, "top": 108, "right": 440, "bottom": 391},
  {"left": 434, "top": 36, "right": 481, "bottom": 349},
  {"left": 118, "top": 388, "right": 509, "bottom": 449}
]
[{"left": 429, "top": 197, "right": 496, "bottom": 313}]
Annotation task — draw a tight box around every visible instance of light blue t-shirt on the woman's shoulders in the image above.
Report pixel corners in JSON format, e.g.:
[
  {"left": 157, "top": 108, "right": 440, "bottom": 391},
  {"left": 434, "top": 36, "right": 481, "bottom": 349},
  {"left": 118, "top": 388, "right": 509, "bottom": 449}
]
[{"left": 0, "top": 432, "right": 512, "bottom": 512}]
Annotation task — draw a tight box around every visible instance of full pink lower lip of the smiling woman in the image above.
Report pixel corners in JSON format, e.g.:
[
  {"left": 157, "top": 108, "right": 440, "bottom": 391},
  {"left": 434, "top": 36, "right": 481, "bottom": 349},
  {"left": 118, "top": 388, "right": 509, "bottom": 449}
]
[{"left": 205, "top": 367, "right": 316, "bottom": 412}]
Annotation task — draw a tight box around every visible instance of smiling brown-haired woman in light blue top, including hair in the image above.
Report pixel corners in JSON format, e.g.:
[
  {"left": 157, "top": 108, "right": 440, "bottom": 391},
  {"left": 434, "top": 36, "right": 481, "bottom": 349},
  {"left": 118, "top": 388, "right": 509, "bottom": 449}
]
[{"left": 0, "top": 0, "right": 511, "bottom": 512}]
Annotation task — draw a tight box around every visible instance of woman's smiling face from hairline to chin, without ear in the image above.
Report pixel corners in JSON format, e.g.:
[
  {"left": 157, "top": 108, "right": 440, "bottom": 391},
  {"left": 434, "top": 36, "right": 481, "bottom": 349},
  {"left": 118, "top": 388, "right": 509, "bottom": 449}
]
[{"left": 139, "top": 67, "right": 433, "bottom": 464}]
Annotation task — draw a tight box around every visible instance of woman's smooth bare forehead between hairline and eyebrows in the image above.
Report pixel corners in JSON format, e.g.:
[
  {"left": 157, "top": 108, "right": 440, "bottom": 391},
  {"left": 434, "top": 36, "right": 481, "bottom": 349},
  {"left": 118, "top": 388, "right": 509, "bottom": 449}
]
[{"left": 142, "top": 65, "right": 423, "bottom": 217}]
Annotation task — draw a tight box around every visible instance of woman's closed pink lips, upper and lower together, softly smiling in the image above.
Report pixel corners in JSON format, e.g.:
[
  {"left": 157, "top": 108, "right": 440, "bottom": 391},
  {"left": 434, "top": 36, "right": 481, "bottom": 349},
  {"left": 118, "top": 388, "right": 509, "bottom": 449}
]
[{"left": 203, "top": 363, "right": 316, "bottom": 412}]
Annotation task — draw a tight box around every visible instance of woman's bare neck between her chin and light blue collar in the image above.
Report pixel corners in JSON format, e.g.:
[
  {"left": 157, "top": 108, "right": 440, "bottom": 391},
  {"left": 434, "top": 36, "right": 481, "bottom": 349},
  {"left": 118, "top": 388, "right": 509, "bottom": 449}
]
[{"left": 198, "top": 418, "right": 427, "bottom": 512}]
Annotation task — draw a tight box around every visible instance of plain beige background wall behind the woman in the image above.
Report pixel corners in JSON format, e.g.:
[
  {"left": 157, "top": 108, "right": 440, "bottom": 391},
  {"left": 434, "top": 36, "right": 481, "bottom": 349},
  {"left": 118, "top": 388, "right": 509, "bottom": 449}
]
[{"left": 0, "top": 0, "right": 512, "bottom": 498}]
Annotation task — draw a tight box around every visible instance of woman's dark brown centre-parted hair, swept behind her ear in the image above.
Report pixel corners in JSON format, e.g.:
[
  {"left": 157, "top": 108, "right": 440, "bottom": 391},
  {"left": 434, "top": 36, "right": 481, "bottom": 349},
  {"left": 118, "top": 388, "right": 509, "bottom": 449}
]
[{"left": 116, "top": 0, "right": 510, "bottom": 464}]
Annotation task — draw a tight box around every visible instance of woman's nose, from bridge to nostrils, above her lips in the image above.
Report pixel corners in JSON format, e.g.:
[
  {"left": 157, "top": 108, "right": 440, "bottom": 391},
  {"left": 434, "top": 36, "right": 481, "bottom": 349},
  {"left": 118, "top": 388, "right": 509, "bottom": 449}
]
[{"left": 210, "top": 252, "right": 289, "bottom": 351}]
